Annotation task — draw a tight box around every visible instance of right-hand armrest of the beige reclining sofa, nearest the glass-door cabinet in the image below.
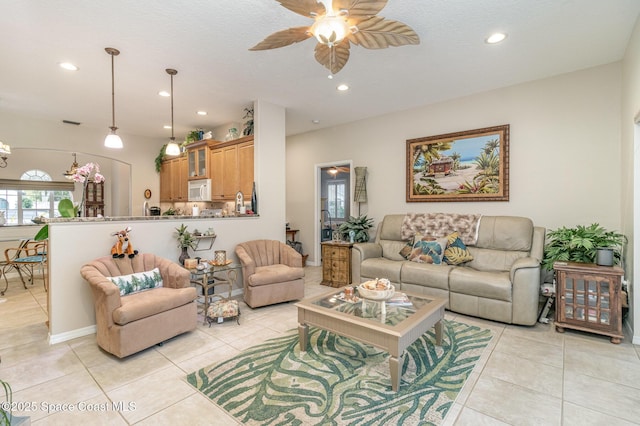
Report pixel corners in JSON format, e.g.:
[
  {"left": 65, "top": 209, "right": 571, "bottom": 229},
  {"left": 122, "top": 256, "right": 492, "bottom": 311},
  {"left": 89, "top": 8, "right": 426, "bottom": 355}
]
[{"left": 509, "top": 257, "right": 540, "bottom": 325}]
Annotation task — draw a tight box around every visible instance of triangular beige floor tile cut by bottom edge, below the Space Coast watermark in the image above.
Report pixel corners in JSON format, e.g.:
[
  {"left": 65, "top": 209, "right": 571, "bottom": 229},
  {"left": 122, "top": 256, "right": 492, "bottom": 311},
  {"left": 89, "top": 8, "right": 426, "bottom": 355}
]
[{"left": 32, "top": 394, "right": 128, "bottom": 426}]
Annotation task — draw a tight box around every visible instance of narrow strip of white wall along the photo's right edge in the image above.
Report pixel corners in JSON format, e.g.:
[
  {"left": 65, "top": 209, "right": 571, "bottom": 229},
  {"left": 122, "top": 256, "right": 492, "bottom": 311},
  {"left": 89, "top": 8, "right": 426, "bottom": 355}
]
[{"left": 620, "top": 15, "right": 640, "bottom": 345}]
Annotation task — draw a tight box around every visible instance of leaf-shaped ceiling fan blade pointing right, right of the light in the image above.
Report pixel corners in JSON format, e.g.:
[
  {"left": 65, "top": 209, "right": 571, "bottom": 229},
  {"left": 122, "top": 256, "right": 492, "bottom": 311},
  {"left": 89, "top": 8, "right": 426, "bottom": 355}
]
[{"left": 349, "top": 16, "right": 420, "bottom": 49}]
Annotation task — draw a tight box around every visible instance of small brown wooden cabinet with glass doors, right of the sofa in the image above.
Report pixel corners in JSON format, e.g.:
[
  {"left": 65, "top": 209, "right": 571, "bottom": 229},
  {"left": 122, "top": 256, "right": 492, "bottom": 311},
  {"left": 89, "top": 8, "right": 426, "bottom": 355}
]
[{"left": 553, "top": 262, "right": 624, "bottom": 343}]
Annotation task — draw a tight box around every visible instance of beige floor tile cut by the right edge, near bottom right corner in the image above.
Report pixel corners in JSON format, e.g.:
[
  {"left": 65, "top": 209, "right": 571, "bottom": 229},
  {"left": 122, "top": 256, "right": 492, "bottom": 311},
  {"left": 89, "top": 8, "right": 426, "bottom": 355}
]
[{"left": 564, "top": 371, "right": 640, "bottom": 422}]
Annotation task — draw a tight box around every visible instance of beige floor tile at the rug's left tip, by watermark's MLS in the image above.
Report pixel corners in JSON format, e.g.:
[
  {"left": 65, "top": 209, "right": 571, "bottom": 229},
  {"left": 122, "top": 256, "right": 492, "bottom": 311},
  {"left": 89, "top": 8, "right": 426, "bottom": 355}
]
[{"left": 107, "top": 365, "right": 197, "bottom": 423}]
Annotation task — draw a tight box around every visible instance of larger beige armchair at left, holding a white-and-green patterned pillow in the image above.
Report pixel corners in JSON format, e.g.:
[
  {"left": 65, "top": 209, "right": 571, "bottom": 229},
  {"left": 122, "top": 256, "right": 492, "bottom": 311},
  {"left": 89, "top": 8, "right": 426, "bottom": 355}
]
[{"left": 80, "top": 253, "right": 197, "bottom": 358}]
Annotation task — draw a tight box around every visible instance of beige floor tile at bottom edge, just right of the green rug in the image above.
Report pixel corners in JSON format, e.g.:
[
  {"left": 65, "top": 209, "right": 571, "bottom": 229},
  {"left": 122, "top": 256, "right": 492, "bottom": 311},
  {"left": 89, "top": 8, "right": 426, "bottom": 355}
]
[{"left": 465, "top": 376, "right": 562, "bottom": 425}]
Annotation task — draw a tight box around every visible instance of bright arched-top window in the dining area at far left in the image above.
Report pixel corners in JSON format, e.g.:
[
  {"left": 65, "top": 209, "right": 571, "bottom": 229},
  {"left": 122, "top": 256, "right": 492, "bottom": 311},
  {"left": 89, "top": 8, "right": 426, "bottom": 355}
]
[{"left": 0, "top": 170, "right": 73, "bottom": 225}]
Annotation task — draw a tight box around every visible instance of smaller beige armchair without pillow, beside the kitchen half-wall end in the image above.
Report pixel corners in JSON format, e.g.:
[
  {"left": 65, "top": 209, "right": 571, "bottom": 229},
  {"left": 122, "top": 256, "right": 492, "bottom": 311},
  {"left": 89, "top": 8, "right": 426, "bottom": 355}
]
[{"left": 236, "top": 240, "right": 304, "bottom": 308}]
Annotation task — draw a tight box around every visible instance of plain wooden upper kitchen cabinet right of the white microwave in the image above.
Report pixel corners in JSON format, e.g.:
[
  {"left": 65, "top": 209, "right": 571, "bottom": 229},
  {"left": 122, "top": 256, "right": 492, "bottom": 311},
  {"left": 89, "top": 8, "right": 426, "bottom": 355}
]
[{"left": 209, "top": 136, "right": 253, "bottom": 201}]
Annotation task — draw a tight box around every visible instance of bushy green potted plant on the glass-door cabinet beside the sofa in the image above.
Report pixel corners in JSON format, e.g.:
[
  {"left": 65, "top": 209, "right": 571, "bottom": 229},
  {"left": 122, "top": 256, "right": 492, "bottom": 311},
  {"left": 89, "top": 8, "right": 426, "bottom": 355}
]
[{"left": 542, "top": 223, "right": 627, "bottom": 271}]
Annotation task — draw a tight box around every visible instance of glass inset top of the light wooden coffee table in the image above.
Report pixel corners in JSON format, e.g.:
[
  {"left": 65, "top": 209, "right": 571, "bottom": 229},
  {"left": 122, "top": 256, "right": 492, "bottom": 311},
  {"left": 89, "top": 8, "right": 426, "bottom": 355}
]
[{"left": 311, "top": 289, "right": 432, "bottom": 326}]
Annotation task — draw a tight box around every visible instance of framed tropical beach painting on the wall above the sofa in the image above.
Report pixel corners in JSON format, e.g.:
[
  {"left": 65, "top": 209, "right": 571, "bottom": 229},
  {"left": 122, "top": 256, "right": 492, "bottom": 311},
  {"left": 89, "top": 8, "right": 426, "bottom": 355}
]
[{"left": 407, "top": 124, "right": 509, "bottom": 202}]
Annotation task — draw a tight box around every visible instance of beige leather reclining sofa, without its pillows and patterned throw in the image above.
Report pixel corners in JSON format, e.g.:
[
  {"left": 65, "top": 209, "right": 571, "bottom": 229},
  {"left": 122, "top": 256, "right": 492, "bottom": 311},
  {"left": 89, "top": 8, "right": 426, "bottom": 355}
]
[{"left": 352, "top": 214, "right": 545, "bottom": 325}]
